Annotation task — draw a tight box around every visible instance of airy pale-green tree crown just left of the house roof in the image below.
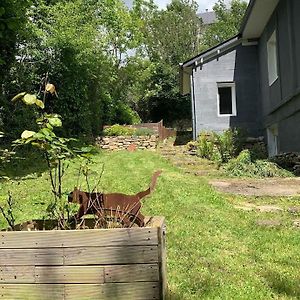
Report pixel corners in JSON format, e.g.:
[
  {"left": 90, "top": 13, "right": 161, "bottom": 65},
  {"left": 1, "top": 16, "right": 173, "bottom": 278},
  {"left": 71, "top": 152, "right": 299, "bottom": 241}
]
[{"left": 145, "top": 0, "right": 202, "bottom": 65}]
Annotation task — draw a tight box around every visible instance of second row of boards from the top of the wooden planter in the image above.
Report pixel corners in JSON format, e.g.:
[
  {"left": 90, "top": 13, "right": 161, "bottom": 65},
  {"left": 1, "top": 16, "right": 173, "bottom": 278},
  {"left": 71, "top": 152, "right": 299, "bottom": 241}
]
[{"left": 0, "top": 246, "right": 158, "bottom": 266}]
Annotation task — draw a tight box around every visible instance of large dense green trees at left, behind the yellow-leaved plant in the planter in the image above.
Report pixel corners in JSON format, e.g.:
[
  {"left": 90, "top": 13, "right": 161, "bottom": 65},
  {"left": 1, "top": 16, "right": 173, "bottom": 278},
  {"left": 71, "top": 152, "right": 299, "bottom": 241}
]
[{"left": 0, "top": 0, "right": 142, "bottom": 139}]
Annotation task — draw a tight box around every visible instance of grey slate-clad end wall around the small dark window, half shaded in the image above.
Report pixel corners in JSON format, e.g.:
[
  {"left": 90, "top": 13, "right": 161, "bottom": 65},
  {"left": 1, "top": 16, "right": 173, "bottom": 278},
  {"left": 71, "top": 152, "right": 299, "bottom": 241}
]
[{"left": 194, "top": 45, "right": 261, "bottom": 136}]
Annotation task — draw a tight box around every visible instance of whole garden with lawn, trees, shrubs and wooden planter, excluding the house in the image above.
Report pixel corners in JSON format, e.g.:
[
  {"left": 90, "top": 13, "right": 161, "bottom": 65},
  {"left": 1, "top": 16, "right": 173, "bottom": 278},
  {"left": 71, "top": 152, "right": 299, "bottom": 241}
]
[{"left": 0, "top": 0, "right": 300, "bottom": 300}]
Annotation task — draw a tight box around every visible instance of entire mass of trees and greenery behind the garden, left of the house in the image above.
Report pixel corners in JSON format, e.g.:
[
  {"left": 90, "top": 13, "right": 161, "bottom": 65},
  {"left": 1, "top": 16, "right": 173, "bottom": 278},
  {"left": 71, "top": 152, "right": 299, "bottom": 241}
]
[{"left": 0, "top": 0, "right": 248, "bottom": 140}]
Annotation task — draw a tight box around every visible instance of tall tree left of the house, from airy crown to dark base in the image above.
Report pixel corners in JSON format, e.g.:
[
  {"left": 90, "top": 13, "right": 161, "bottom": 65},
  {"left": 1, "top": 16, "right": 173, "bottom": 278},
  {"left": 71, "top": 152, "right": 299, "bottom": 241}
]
[{"left": 137, "top": 0, "right": 203, "bottom": 125}]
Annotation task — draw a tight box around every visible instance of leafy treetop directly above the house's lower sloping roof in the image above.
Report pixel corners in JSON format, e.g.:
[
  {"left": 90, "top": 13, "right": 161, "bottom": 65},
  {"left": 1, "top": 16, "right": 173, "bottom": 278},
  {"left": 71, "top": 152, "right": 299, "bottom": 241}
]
[{"left": 203, "top": 0, "right": 247, "bottom": 48}]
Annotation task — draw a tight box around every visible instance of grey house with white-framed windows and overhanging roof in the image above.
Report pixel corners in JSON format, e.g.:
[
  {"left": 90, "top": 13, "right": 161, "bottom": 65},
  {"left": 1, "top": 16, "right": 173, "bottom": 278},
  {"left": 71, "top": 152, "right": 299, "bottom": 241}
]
[{"left": 180, "top": 0, "right": 300, "bottom": 156}]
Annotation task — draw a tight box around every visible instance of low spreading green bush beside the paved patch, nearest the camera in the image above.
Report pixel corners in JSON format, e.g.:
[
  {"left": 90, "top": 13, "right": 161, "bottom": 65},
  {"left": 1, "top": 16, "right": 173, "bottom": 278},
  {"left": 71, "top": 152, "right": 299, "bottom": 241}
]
[{"left": 224, "top": 150, "right": 293, "bottom": 178}]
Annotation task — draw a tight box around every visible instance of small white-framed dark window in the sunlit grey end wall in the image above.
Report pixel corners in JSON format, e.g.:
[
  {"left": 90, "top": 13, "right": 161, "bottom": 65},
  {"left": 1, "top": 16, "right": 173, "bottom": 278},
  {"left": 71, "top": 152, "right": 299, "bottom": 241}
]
[{"left": 218, "top": 82, "right": 236, "bottom": 116}]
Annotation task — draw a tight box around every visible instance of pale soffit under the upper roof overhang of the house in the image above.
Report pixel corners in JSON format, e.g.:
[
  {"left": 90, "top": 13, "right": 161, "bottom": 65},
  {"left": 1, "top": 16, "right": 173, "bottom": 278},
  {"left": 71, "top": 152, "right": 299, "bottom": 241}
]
[{"left": 242, "top": 0, "right": 279, "bottom": 39}]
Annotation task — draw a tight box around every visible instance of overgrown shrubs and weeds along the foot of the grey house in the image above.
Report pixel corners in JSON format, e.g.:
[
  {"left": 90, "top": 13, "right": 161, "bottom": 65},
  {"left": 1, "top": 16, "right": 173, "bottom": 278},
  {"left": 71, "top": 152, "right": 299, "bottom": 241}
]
[{"left": 195, "top": 129, "right": 293, "bottom": 178}]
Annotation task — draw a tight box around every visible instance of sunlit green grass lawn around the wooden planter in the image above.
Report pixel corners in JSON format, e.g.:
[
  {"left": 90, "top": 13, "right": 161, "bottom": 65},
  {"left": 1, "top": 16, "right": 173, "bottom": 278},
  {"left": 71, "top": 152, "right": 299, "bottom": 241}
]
[{"left": 0, "top": 151, "right": 300, "bottom": 300}]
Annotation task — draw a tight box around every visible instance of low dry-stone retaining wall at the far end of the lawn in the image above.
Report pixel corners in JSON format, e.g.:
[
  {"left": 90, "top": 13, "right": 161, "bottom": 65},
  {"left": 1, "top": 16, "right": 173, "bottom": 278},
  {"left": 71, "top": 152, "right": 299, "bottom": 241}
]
[{"left": 96, "top": 135, "right": 158, "bottom": 150}]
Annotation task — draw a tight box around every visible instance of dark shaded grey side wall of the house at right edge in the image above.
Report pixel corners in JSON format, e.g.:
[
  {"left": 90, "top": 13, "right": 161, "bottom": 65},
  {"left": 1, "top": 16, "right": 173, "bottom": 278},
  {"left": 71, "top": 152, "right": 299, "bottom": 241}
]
[{"left": 259, "top": 0, "right": 300, "bottom": 152}]
